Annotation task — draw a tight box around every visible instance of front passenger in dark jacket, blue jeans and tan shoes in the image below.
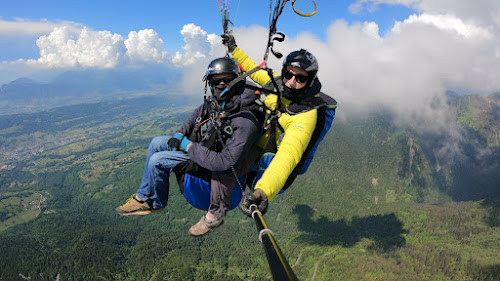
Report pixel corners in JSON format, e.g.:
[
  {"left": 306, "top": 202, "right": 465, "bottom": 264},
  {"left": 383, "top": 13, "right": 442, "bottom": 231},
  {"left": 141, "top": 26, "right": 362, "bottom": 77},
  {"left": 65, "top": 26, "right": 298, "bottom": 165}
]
[{"left": 115, "top": 57, "right": 261, "bottom": 236}]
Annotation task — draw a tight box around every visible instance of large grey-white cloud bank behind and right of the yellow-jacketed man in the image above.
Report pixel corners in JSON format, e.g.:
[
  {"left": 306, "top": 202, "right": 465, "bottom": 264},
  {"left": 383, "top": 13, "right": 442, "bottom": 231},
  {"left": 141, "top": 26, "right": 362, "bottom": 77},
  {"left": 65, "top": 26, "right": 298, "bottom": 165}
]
[{"left": 230, "top": 4, "right": 500, "bottom": 136}]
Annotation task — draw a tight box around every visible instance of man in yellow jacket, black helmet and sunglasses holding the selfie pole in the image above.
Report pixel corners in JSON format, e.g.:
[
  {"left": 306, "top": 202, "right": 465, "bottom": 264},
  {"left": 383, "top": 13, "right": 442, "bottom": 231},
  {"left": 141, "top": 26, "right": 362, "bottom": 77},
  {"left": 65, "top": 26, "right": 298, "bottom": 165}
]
[{"left": 221, "top": 33, "right": 336, "bottom": 215}]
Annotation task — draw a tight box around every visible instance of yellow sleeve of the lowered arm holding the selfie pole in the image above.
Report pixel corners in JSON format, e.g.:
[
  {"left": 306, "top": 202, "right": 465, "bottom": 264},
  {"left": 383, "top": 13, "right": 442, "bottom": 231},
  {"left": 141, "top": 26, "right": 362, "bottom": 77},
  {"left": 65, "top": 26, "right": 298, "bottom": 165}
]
[{"left": 255, "top": 109, "right": 318, "bottom": 200}]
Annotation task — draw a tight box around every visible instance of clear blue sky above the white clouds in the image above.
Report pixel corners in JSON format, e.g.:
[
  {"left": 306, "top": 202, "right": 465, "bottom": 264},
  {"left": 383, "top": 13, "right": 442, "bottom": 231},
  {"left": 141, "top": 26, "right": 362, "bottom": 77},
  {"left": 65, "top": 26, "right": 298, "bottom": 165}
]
[{"left": 0, "top": 0, "right": 415, "bottom": 61}]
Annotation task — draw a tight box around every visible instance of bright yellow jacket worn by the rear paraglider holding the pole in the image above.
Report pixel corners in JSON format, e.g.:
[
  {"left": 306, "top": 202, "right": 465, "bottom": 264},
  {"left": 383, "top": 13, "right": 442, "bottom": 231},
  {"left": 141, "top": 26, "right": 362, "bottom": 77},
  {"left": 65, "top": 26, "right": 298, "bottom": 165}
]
[{"left": 232, "top": 47, "right": 318, "bottom": 200}]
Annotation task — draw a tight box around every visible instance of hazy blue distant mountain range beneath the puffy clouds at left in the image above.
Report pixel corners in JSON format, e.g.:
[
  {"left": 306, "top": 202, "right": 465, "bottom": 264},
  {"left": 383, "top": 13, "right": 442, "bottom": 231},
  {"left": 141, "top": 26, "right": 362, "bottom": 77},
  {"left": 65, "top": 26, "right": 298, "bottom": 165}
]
[{"left": 0, "top": 67, "right": 180, "bottom": 115}]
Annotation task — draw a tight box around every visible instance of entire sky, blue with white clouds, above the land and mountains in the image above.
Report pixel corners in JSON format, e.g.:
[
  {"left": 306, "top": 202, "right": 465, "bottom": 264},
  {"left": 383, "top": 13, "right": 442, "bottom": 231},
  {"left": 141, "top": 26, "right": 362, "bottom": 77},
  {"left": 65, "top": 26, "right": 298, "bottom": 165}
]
[{"left": 0, "top": 0, "right": 500, "bottom": 148}]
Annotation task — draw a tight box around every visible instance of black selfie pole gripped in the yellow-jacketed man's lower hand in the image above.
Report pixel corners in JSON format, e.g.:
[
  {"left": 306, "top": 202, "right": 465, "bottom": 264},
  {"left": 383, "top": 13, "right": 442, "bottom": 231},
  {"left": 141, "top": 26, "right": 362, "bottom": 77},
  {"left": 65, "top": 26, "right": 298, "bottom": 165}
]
[{"left": 250, "top": 205, "right": 298, "bottom": 281}]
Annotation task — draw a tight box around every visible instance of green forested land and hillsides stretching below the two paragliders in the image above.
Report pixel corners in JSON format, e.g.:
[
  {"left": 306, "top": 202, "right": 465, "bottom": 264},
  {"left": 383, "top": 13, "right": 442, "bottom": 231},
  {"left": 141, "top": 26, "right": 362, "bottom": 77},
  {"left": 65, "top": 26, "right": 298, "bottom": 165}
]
[{"left": 0, "top": 95, "right": 500, "bottom": 281}]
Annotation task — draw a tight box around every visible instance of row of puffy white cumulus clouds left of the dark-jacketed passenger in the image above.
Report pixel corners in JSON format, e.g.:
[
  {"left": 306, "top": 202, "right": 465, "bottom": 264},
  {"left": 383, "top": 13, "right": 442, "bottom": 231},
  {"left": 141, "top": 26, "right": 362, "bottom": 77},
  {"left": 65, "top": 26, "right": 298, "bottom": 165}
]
[{"left": 18, "top": 24, "right": 222, "bottom": 68}]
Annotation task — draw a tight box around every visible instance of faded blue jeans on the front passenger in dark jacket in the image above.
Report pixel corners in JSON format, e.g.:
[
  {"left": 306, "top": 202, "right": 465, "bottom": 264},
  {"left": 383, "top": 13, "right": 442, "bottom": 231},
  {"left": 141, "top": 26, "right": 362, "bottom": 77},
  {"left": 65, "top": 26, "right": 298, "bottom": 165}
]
[{"left": 136, "top": 136, "right": 189, "bottom": 209}]
